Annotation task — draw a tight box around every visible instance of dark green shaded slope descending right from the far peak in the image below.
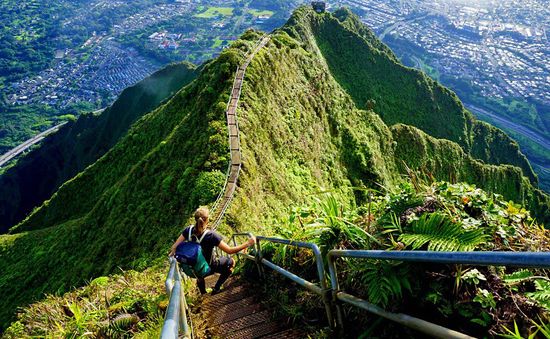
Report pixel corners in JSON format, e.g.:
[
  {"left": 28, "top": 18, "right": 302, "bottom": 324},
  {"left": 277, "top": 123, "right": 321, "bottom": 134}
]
[{"left": 298, "top": 9, "right": 537, "bottom": 184}]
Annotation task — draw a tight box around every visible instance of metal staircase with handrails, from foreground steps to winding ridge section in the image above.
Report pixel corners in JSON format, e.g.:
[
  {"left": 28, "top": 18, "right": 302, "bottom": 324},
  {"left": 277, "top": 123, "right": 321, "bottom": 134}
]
[{"left": 161, "top": 35, "right": 550, "bottom": 339}]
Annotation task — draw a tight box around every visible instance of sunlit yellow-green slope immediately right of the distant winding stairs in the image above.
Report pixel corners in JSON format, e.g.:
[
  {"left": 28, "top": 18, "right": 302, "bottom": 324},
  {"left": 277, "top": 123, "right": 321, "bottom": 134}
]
[{"left": 229, "top": 33, "right": 402, "bottom": 227}]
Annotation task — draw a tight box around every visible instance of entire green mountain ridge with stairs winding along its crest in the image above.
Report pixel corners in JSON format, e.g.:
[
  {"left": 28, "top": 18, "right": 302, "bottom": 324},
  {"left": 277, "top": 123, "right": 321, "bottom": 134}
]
[{"left": 0, "top": 7, "right": 550, "bottom": 334}]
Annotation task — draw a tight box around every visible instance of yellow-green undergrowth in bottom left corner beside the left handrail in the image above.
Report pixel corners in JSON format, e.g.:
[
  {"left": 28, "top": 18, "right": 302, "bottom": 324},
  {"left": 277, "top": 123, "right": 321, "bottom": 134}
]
[{"left": 3, "top": 266, "right": 168, "bottom": 339}]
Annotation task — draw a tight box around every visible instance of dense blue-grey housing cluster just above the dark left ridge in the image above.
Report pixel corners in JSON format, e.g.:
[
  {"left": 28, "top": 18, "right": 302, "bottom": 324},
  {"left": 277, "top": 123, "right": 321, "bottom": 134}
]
[{"left": 8, "top": 38, "right": 161, "bottom": 110}]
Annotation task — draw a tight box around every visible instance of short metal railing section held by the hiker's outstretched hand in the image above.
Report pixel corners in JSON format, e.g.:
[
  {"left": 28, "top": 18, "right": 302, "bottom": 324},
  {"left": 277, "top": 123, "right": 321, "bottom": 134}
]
[{"left": 232, "top": 232, "right": 334, "bottom": 327}]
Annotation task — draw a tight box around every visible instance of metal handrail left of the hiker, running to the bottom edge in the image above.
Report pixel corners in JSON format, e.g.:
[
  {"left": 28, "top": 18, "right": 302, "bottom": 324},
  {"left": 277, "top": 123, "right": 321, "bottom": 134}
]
[{"left": 160, "top": 257, "right": 193, "bottom": 339}]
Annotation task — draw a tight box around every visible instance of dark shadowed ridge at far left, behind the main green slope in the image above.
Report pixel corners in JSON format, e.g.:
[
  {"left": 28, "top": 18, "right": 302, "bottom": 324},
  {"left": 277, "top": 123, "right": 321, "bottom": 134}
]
[{"left": 0, "top": 63, "right": 196, "bottom": 233}]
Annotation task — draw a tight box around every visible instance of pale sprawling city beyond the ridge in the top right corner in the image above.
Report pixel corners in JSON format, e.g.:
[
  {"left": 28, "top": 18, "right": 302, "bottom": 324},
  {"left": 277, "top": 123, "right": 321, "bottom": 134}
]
[{"left": 338, "top": 0, "right": 550, "bottom": 105}]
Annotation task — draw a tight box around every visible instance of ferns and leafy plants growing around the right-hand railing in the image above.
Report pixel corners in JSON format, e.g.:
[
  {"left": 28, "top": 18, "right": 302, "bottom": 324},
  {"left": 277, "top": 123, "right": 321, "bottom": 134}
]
[{"left": 260, "top": 183, "right": 550, "bottom": 336}]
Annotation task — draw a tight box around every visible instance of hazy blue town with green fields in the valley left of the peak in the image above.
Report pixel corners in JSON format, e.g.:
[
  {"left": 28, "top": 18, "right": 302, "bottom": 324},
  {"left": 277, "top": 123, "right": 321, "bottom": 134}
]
[{"left": 2, "top": 0, "right": 282, "bottom": 113}]
